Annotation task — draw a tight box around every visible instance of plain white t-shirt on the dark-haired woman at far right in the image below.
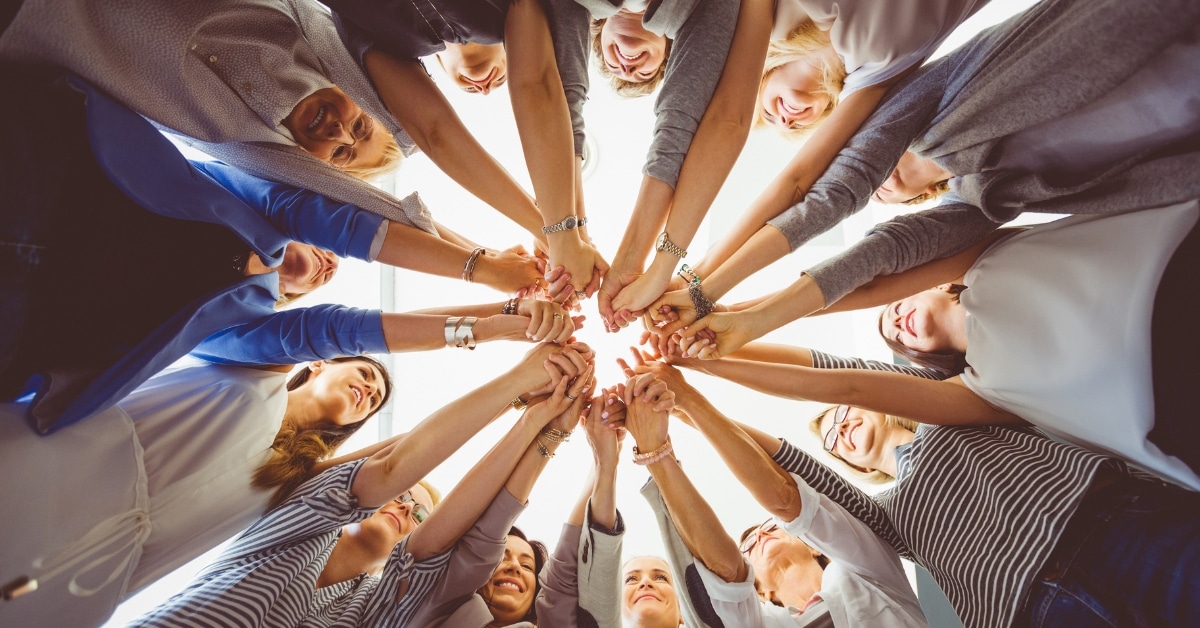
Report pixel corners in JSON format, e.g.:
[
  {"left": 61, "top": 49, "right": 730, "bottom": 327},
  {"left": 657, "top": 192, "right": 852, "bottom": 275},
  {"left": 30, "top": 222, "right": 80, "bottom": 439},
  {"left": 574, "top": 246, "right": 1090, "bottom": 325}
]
[{"left": 960, "top": 201, "right": 1200, "bottom": 490}]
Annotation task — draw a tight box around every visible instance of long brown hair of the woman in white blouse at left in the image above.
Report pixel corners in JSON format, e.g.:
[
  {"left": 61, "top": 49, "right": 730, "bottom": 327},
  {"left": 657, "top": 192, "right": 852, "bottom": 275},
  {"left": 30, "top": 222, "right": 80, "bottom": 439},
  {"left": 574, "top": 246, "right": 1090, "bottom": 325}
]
[{"left": 251, "top": 355, "right": 393, "bottom": 509}]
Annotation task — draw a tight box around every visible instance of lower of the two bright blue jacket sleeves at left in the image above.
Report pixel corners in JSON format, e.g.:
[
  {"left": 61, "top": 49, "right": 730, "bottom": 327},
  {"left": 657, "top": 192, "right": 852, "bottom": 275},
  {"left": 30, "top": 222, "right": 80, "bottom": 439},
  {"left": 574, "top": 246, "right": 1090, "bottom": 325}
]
[{"left": 192, "top": 305, "right": 388, "bottom": 365}]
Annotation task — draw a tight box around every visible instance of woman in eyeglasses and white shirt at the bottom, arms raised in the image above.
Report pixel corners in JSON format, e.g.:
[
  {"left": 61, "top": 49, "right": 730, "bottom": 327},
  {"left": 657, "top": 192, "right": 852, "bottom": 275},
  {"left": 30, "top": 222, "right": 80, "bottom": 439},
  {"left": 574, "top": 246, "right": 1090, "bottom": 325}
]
[{"left": 625, "top": 365, "right": 928, "bottom": 627}]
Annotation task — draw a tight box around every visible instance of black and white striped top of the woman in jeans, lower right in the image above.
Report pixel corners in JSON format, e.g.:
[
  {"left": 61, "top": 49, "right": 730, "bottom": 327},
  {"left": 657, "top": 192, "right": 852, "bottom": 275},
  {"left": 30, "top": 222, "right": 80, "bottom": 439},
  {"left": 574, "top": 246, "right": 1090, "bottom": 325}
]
[{"left": 774, "top": 425, "right": 1126, "bottom": 628}]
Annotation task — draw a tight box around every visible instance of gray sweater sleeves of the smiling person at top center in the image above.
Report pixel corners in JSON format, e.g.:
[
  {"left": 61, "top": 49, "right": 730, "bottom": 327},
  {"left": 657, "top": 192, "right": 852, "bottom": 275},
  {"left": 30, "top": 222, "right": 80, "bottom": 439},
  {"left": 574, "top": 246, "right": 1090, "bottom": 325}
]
[{"left": 550, "top": 0, "right": 742, "bottom": 187}]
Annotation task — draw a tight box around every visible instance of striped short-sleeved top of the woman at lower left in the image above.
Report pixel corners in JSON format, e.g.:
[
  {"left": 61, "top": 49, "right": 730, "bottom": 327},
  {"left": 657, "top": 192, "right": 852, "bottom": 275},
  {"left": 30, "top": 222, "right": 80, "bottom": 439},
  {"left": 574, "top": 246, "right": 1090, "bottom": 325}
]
[{"left": 130, "top": 460, "right": 450, "bottom": 628}]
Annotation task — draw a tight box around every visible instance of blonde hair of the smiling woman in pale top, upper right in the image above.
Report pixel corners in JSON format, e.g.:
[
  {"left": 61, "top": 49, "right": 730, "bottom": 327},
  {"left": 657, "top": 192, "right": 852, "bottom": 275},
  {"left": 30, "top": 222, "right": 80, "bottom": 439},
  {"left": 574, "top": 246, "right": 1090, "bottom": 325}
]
[{"left": 755, "top": 19, "right": 846, "bottom": 138}]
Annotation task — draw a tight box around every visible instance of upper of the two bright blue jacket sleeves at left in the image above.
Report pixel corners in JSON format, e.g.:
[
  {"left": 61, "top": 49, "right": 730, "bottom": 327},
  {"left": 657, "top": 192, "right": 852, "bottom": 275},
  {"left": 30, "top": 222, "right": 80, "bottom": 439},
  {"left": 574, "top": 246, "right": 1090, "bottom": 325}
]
[{"left": 192, "top": 161, "right": 385, "bottom": 259}]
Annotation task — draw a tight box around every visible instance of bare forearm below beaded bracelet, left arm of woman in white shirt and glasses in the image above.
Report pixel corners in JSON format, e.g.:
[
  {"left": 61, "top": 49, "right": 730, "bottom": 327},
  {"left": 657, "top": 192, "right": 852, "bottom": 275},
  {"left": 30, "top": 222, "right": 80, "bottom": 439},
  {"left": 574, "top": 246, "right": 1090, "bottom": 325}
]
[{"left": 649, "top": 455, "right": 746, "bottom": 582}]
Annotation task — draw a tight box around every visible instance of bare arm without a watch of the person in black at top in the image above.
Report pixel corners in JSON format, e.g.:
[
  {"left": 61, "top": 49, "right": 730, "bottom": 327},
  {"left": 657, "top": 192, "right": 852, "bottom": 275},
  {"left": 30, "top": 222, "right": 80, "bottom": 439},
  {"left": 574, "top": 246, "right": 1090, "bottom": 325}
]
[{"left": 362, "top": 49, "right": 544, "bottom": 239}]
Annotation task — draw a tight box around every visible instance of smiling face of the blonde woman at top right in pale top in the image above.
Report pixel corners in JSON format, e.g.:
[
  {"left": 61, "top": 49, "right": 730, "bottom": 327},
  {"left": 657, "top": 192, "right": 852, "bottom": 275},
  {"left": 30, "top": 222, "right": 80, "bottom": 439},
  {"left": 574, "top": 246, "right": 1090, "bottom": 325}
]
[{"left": 758, "top": 56, "right": 833, "bottom": 131}]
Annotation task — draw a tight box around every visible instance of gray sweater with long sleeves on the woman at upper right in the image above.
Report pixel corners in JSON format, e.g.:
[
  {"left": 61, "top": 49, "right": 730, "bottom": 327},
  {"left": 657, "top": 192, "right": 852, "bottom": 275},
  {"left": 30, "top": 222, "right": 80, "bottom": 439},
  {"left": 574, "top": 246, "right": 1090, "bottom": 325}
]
[{"left": 769, "top": 0, "right": 1200, "bottom": 303}]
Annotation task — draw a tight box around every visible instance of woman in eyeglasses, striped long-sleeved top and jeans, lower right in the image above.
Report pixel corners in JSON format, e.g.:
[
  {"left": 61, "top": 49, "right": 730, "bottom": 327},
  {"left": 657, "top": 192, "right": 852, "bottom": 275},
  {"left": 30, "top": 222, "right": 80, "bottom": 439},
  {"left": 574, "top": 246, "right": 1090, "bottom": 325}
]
[{"left": 657, "top": 343, "right": 1200, "bottom": 628}]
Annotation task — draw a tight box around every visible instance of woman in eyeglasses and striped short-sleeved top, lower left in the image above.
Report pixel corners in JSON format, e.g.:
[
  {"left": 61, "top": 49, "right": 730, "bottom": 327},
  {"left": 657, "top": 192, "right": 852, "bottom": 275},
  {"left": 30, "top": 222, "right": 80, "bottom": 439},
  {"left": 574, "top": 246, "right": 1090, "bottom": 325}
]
[{"left": 134, "top": 346, "right": 592, "bottom": 626}]
